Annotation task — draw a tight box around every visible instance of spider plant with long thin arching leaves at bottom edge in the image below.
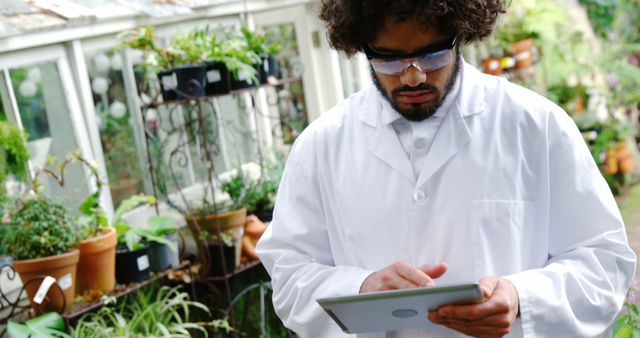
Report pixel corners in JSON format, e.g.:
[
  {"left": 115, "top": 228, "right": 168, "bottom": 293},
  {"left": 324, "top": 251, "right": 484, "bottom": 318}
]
[{"left": 71, "top": 286, "right": 222, "bottom": 338}]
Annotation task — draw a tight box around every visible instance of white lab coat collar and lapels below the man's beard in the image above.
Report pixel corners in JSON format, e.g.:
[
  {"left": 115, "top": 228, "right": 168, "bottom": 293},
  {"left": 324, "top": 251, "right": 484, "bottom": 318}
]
[{"left": 361, "top": 61, "right": 484, "bottom": 187}]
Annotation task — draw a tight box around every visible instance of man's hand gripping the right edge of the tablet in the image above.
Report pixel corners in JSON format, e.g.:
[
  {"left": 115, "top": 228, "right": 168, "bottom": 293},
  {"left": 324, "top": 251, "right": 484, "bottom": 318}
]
[{"left": 429, "top": 277, "right": 520, "bottom": 338}]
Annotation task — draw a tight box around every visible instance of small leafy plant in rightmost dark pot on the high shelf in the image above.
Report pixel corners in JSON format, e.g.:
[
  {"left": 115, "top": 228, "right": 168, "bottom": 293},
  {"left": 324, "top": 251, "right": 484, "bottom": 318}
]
[{"left": 240, "top": 27, "right": 282, "bottom": 84}]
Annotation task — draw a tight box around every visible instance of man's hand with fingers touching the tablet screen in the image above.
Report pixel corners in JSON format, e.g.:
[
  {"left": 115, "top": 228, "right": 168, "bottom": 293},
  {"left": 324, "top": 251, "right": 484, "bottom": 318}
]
[{"left": 360, "top": 262, "right": 447, "bottom": 293}]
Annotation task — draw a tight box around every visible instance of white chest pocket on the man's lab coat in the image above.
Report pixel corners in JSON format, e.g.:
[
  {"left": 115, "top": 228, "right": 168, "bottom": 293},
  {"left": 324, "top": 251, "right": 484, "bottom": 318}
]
[{"left": 470, "top": 200, "right": 536, "bottom": 278}]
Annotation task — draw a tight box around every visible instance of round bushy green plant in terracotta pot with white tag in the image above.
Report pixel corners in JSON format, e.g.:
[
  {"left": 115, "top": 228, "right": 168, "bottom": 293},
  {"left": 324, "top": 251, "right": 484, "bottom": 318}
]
[{"left": 4, "top": 194, "right": 80, "bottom": 312}]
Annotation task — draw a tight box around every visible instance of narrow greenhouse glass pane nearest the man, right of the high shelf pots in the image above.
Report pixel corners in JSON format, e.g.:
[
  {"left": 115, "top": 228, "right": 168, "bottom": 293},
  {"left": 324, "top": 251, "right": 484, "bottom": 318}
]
[{"left": 263, "top": 23, "right": 309, "bottom": 144}]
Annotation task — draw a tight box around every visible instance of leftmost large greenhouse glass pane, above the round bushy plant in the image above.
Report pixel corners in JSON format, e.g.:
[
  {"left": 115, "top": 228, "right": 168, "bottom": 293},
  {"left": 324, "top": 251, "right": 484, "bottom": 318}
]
[{"left": 9, "top": 61, "right": 88, "bottom": 209}]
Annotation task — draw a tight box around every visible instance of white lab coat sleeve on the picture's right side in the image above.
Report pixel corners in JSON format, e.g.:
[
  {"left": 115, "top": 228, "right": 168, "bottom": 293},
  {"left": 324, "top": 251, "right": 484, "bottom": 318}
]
[{"left": 507, "top": 111, "right": 636, "bottom": 337}]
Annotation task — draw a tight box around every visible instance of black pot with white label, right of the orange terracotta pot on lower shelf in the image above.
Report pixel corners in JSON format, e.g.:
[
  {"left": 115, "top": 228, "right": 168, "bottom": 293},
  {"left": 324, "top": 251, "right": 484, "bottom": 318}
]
[{"left": 116, "top": 245, "right": 151, "bottom": 284}]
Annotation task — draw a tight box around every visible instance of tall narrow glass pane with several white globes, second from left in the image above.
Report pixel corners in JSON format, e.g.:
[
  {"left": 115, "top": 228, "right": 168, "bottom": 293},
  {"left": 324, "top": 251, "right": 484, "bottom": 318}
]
[{"left": 85, "top": 51, "right": 143, "bottom": 208}]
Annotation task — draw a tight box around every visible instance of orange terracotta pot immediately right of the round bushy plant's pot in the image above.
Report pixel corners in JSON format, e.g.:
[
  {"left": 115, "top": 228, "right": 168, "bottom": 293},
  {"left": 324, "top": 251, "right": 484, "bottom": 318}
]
[{"left": 77, "top": 228, "right": 118, "bottom": 294}]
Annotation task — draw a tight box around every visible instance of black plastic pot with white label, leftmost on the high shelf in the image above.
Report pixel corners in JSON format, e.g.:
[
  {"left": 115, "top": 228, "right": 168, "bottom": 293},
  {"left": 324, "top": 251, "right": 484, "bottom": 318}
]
[{"left": 158, "top": 65, "right": 206, "bottom": 101}]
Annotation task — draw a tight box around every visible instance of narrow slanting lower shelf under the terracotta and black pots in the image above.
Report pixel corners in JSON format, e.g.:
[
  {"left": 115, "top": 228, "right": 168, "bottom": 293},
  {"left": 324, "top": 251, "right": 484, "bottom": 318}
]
[{"left": 62, "top": 261, "right": 191, "bottom": 322}]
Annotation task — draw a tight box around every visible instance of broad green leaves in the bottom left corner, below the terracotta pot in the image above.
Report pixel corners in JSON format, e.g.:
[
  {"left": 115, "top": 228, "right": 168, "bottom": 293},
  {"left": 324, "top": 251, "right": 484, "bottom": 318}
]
[{"left": 7, "top": 312, "right": 71, "bottom": 338}]
